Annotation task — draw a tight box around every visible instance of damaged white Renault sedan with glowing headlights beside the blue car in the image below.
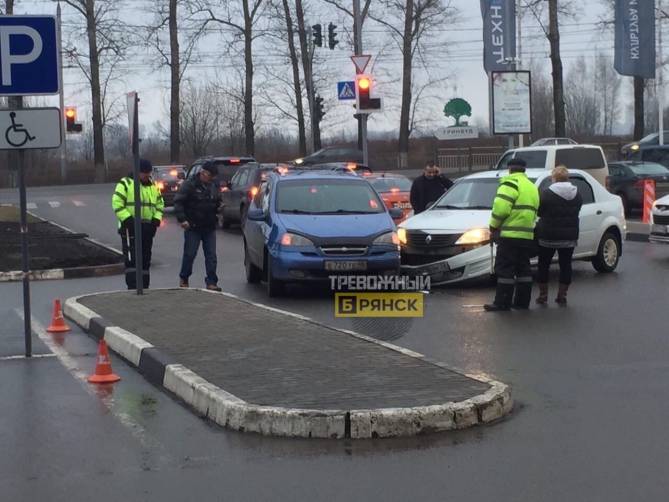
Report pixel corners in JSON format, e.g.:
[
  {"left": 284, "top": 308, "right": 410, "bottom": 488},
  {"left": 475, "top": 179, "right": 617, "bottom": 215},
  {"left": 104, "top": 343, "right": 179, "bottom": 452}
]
[{"left": 398, "top": 169, "right": 626, "bottom": 285}]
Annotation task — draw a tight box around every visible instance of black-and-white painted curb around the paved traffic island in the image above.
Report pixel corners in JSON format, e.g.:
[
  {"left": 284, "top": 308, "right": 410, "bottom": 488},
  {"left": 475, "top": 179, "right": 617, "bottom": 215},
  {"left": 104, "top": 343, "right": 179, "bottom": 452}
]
[{"left": 64, "top": 288, "right": 513, "bottom": 439}]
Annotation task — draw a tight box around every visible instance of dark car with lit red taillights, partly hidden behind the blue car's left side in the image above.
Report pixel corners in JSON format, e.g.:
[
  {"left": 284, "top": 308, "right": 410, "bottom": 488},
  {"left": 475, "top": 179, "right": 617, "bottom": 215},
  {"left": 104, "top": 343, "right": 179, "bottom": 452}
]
[{"left": 219, "top": 163, "right": 288, "bottom": 228}]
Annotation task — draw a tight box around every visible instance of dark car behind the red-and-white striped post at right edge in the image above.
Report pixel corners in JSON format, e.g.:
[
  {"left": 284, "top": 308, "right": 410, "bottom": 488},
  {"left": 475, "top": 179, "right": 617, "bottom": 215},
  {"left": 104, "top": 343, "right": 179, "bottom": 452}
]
[{"left": 606, "top": 161, "right": 669, "bottom": 216}]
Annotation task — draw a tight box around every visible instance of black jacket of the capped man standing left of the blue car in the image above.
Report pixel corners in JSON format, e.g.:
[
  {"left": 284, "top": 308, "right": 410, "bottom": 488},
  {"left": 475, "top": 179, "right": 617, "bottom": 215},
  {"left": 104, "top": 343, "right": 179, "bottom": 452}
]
[{"left": 174, "top": 177, "right": 221, "bottom": 230}]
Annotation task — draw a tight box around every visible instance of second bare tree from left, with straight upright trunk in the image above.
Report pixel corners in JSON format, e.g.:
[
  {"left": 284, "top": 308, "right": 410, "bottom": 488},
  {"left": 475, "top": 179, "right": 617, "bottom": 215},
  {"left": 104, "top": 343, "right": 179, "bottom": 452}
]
[{"left": 148, "top": 0, "right": 205, "bottom": 163}]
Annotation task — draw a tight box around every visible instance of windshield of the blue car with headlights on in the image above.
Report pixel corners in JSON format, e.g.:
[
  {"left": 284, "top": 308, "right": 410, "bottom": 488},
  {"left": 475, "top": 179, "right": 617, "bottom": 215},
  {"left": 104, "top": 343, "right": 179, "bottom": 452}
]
[{"left": 276, "top": 179, "right": 385, "bottom": 214}]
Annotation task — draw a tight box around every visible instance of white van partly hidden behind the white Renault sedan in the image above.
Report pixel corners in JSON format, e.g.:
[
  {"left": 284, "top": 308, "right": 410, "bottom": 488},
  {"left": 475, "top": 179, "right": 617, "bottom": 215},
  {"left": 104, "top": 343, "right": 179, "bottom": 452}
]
[{"left": 494, "top": 145, "right": 609, "bottom": 186}]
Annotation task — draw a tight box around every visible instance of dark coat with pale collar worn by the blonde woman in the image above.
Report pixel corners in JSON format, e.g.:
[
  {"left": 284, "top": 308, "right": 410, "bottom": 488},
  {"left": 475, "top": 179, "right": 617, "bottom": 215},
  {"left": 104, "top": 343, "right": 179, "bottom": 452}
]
[{"left": 535, "top": 182, "right": 583, "bottom": 247}]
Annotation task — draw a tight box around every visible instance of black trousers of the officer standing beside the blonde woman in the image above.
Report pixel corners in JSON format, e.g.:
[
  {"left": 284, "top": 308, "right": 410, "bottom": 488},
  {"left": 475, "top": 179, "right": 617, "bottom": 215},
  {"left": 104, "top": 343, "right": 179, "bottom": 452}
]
[{"left": 495, "top": 239, "right": 533, "bottom": 308}]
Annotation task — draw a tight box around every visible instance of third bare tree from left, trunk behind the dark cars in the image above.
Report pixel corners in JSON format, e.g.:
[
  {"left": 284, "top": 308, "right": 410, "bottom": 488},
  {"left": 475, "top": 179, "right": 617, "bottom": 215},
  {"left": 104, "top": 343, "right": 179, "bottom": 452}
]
[{"left": 196, "top": 0, "right": 264, "bottom": 155}]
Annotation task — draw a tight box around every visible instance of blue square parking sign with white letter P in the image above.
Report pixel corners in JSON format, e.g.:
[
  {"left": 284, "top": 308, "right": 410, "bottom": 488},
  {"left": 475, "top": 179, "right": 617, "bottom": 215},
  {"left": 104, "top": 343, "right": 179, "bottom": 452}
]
[{"left": 0, "top": 16, "right": 59, "bottom": 96}]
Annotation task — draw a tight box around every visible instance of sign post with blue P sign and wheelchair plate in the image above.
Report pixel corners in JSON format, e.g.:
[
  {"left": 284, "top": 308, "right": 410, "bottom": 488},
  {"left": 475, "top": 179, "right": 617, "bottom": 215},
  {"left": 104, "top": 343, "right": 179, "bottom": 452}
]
[{"left": 0, "top": 15, "right": 62, "bottom": 357}]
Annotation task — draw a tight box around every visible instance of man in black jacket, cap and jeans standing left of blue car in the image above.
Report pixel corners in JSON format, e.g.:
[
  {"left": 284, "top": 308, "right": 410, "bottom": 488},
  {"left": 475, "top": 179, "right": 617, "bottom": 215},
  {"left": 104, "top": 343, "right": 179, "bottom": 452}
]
[{"left": 174, "top": 161, "right": 221, "bottom": 291}]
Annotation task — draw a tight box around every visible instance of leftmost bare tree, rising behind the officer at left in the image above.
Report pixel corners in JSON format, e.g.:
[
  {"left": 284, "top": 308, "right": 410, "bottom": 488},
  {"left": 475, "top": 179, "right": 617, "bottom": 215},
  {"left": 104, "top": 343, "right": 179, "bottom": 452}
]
[{"left": 64, "top": 0, "right": 129, "bottom": 182}]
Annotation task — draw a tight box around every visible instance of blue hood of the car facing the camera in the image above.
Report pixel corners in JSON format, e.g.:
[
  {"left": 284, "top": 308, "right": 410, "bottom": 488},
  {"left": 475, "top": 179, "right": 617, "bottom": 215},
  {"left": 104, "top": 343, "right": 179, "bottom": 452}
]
[{"left": 277, "top": 212, "right": 394, "bottom": 239}]
